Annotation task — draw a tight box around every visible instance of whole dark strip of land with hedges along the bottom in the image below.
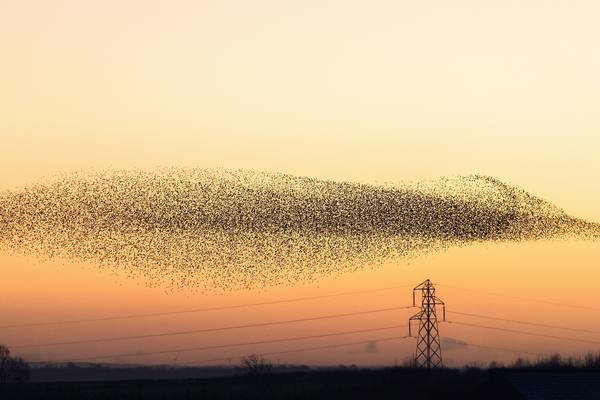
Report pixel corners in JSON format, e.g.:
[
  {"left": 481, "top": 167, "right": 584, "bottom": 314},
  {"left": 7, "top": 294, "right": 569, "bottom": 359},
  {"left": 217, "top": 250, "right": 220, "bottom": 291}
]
[{"left": 5, "top": 353, "right": 600, "bottom": 400}]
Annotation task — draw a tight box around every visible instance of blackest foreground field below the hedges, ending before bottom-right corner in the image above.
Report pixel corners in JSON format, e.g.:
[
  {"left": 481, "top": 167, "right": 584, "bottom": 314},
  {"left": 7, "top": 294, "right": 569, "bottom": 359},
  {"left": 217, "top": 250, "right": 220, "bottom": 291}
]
[{"left": 0, "top": 368, "right": 525, "bottom": 400}]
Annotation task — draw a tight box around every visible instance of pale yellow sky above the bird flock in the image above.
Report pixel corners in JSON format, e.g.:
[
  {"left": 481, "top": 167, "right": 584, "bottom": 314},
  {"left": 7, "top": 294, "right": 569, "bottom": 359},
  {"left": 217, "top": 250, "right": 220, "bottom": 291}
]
[{"left": 0, "top": 0, "right": 600, "bottom": 219}]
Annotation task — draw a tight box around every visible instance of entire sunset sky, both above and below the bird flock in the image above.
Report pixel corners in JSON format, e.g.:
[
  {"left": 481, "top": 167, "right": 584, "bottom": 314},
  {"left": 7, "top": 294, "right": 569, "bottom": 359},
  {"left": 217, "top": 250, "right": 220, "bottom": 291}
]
[{"left": 0, "top": 0, "right": 600, "bottom": 364}]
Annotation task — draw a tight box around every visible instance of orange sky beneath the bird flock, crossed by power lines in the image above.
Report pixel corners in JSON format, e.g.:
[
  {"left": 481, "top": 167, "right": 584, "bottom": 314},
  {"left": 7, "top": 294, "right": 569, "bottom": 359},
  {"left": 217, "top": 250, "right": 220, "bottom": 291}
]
[{"left": 1, "top": 242, "right": 600, "bottom": 365}]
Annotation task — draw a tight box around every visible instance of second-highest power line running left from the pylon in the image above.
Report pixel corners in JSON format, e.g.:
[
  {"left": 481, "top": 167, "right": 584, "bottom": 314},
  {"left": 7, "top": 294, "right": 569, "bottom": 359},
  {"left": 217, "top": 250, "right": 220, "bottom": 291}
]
[{"left": 12, "top": 306, "right": 412, "bottom": 349}]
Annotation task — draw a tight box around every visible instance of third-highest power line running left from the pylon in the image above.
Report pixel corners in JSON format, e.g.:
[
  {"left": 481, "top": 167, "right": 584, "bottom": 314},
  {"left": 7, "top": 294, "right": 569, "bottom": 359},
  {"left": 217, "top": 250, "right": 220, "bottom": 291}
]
[{"left": 37, "top": 325, "right": 407, "bottom": 364}]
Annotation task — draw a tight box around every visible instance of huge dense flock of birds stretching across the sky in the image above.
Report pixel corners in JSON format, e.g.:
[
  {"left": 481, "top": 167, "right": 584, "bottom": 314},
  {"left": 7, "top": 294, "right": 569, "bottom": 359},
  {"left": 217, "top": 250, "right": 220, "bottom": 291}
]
[{"left": 0, "top": 169, "right": 600, "bottom": 291}]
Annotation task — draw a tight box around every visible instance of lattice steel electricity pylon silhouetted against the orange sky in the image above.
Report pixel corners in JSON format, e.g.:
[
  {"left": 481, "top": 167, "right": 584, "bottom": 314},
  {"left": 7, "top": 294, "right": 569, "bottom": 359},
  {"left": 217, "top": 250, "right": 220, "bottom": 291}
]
[{"left": 408, "top": 279, "right": 446, "bottom": 369}]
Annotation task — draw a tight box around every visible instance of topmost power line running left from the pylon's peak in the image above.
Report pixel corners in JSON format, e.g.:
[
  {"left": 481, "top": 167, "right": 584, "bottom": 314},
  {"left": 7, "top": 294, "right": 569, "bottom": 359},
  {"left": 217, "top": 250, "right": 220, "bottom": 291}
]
[{"left": 0, "top": 285, "right": 409, "bottom": 329}]
